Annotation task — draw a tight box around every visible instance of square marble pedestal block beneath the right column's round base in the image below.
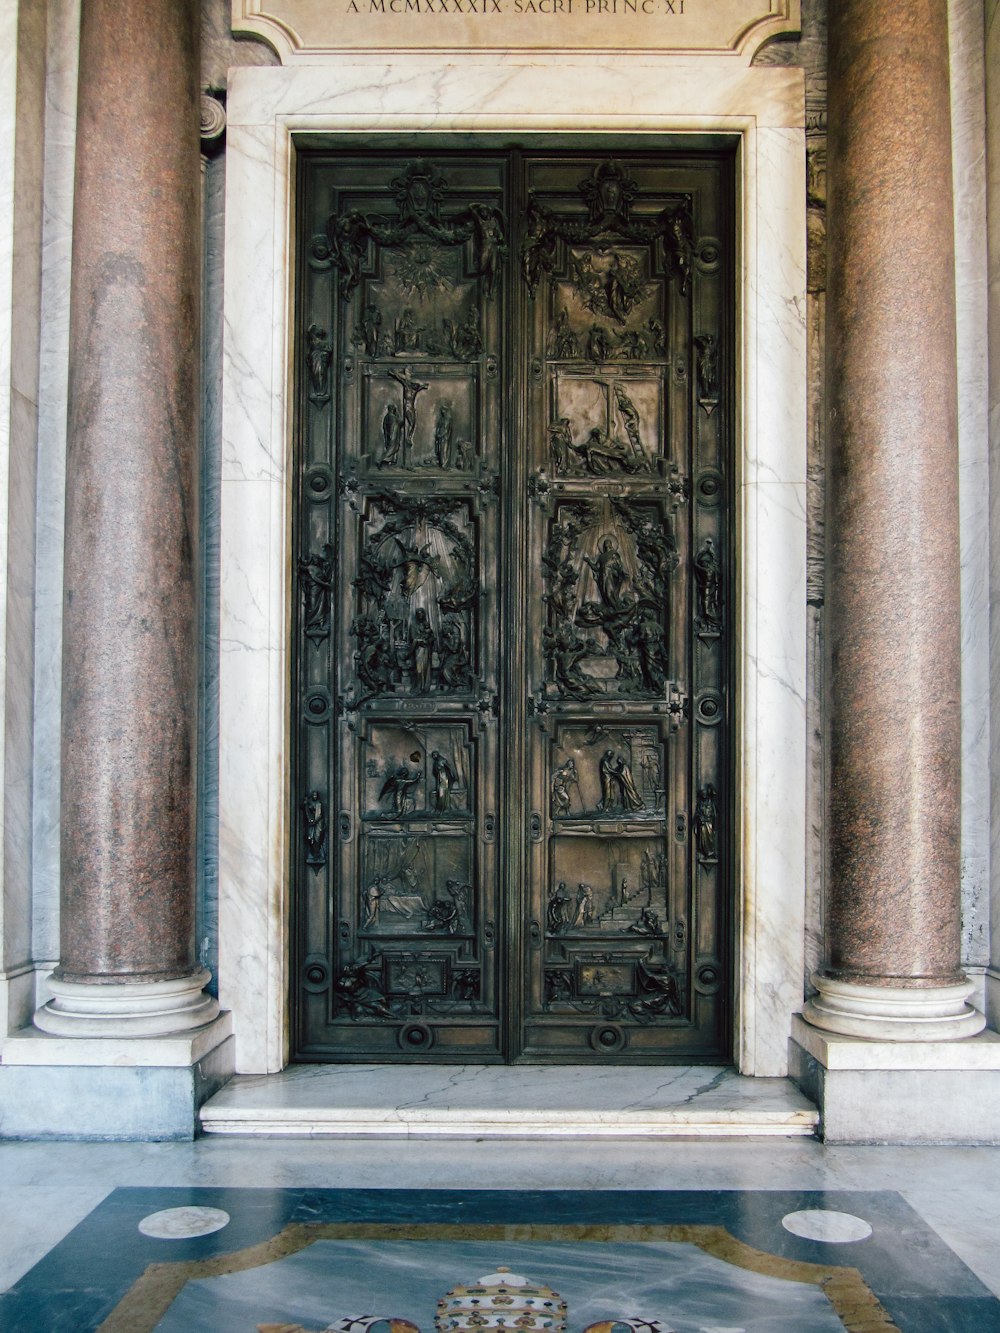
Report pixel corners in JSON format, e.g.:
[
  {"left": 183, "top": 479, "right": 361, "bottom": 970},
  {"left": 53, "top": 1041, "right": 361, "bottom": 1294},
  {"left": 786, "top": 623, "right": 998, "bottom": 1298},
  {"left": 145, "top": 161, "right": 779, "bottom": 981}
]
[{"left": 788, "top": 1014, "right": 1000, "bottom": 1146}]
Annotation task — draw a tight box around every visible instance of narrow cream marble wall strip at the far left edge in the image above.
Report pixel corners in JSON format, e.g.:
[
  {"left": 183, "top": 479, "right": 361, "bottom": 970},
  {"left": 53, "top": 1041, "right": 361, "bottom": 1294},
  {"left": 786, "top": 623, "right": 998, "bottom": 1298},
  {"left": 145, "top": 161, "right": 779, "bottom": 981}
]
[{"left": 0, "top": 0, "right": 45, "bottom": 1036}]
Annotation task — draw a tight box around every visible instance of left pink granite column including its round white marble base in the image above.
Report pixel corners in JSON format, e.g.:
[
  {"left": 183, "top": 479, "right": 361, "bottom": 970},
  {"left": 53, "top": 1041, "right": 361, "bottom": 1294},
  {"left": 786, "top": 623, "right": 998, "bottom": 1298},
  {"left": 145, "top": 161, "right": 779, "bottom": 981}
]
[{"left": 36, "top": 0, "right": 217, "bottom": 1036}]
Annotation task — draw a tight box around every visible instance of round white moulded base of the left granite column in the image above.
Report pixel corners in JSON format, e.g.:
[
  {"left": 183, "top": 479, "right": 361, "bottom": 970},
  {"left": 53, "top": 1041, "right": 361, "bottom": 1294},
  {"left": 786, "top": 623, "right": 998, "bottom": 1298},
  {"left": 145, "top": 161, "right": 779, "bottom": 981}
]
[{"left": 35, "top": 968, "right": 219, "bottom": 1037}]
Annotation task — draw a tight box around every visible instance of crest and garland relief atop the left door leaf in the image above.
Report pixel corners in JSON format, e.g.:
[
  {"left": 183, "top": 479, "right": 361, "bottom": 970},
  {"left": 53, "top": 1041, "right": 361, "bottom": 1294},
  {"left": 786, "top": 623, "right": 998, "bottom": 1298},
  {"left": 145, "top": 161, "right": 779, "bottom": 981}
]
[{"left": 327, "top": 159, "right": 507, "bottom": 299}]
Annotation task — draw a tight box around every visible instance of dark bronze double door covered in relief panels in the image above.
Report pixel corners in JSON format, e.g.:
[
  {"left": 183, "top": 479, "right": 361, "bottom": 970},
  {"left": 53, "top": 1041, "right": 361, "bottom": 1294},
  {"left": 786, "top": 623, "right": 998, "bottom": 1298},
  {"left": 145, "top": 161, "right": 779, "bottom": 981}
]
[{"left": 292, "top": 148, "right": 733, "bottom": 1062}]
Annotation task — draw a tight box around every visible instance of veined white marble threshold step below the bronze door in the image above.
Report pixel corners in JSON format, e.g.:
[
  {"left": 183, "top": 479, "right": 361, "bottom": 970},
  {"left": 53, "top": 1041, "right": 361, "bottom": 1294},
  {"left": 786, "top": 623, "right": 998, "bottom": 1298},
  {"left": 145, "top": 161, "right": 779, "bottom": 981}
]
[{"left": 200, "top": 1065, "right": 820, "bottom": 1138}]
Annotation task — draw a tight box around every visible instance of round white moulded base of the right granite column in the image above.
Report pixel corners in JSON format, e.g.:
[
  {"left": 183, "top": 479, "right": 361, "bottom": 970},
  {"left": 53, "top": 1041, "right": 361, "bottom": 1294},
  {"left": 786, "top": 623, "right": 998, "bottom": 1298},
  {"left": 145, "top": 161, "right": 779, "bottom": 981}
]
[{"left": 803, "top": 973, "right": 987, "bottom": 1041}]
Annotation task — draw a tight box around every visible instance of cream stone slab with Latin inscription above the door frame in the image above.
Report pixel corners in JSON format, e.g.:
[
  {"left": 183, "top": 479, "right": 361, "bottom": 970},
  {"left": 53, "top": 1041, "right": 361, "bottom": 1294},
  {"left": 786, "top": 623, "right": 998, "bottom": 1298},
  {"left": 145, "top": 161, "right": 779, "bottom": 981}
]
[{"left": 233, "top": 0, "right": 800, "bottom": 63}]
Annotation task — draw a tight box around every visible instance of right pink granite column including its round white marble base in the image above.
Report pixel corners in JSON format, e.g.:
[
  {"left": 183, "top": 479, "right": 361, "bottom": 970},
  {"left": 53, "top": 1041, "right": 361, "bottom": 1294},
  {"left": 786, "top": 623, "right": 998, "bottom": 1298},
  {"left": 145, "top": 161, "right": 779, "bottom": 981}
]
[{"left": 804, "top": 0, "right": 983, "bottom": 1041}]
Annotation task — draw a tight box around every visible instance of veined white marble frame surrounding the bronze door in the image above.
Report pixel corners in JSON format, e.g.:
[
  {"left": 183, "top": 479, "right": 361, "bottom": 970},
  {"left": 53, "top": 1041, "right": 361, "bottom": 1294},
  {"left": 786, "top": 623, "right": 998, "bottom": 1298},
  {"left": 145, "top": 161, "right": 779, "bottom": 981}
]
[{"left": 219, "top": 52, "right": 807, "bottom": 1076}]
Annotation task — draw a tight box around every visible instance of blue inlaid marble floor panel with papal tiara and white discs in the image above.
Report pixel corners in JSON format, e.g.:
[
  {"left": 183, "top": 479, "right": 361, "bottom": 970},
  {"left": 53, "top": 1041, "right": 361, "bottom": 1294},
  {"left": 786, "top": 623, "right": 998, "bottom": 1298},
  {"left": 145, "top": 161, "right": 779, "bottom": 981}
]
[{"left": 0, "top": 1188, "right": 1000, "bottom": 1333}]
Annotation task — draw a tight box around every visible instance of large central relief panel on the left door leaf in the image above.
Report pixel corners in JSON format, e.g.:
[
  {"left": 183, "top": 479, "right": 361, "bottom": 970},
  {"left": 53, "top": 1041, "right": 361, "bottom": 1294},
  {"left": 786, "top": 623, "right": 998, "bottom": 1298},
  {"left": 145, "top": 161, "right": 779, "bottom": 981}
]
[{"left": 351, "top": 495, "right": 479, "bottom": 701}]
